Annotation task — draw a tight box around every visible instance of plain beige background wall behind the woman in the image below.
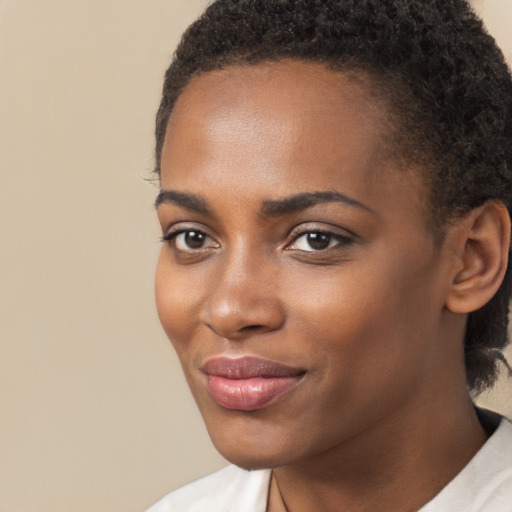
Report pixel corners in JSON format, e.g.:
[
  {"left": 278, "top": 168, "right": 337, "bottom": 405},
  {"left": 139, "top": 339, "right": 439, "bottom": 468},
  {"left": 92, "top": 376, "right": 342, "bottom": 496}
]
[{"left": 0, "top": 0, "right": 512, "bottom": 512}]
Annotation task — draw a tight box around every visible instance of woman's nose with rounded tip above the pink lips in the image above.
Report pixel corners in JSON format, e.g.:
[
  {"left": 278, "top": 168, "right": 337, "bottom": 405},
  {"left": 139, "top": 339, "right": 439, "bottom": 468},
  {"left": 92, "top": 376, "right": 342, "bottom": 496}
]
[{"left": 202, "top": 249, "right": 285, "bottom": 340}]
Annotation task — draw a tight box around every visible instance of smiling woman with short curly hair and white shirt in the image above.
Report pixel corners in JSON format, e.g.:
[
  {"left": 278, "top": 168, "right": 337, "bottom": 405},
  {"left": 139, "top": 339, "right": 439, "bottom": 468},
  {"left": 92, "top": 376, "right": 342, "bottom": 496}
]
[{"left": 146, "top": 0, "right": 512, "bottom": 512}]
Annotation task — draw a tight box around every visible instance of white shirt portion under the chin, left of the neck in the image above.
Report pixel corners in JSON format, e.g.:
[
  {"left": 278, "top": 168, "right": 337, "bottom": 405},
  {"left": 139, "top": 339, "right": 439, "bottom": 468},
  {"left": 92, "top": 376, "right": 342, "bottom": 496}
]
[{"left": 146, "top": 465, "right": 270, "bottom": 512}]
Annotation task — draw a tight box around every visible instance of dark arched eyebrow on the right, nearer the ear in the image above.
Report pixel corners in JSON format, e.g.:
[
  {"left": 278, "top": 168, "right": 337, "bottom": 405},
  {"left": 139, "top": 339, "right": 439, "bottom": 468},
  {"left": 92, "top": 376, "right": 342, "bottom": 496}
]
[{"left": 261, "top": 190, "right": 377, "bottom": 217}]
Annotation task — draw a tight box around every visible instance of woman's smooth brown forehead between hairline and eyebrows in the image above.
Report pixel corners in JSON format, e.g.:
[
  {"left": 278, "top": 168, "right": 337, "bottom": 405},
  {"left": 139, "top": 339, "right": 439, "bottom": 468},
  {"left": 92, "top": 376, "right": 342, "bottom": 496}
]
[{"left": 161, "top": 61, "right": 424, "bottom": 226}]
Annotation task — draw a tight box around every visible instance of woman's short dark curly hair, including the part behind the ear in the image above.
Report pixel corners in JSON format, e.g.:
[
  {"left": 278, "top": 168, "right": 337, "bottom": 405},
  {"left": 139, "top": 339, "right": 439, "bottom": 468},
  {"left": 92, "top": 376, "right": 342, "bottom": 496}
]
[{"left": 155, "top": 0, "right": 512, "bottom": 392}]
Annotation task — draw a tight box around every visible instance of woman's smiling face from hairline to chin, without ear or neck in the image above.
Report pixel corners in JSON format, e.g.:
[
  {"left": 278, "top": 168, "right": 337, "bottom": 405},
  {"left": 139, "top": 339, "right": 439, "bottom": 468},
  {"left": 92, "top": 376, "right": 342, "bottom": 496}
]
[{"left": 156, "top": 62, "right": 452, "bottom": 468}]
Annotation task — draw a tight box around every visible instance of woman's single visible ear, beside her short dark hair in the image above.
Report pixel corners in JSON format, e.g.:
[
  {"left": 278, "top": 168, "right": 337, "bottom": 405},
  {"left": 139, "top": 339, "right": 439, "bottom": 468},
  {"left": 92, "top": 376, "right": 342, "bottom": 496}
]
[{"left": 446, "top": 201, "right": 510, "bottom": 313}]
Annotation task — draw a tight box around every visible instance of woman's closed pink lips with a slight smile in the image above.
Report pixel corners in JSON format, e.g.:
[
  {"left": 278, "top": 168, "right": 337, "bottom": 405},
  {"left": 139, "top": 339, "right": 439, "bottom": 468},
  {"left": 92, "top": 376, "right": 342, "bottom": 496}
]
[{"left": 201, "top": 357, "right": 305, "bottom": 411}]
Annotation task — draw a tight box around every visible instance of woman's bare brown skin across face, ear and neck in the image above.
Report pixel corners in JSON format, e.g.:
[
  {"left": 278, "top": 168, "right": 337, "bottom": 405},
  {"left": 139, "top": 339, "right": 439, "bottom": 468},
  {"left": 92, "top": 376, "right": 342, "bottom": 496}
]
[{"left": 156, "top": 62, "right": 510, "bottom": 512}]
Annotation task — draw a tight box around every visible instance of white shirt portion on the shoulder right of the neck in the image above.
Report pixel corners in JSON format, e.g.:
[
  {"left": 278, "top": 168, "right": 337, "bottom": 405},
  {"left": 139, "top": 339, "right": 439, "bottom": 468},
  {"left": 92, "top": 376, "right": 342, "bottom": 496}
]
[{"left": 421, "top": 418, "right": 512, "bottom": 512}]
